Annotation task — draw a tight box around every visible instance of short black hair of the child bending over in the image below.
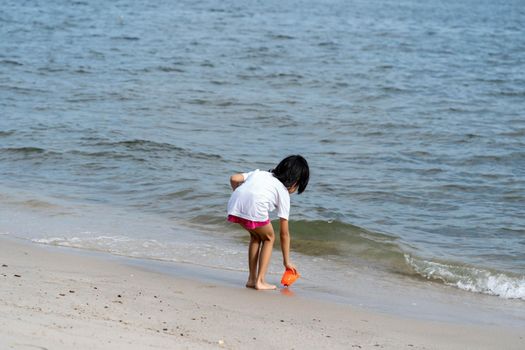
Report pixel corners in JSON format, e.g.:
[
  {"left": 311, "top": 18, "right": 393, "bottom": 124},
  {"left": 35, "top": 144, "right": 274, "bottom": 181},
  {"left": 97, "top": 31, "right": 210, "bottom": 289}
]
[{"left": 270, "top": 155, "right": 310, "bottom": 194}]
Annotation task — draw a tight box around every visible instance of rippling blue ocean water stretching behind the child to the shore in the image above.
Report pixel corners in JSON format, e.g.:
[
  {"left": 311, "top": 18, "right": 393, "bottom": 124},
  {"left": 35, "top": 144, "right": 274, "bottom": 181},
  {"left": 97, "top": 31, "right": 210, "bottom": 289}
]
[{"left": 0, "top": 0, "right": 525, "bottom": 303}]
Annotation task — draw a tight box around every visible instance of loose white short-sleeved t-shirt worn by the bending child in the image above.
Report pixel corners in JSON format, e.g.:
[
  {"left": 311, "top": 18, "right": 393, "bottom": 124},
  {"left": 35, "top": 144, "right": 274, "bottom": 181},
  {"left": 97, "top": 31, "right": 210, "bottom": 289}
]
[{"left": 228, "top": 169, "right": 290, "bottom": 221}]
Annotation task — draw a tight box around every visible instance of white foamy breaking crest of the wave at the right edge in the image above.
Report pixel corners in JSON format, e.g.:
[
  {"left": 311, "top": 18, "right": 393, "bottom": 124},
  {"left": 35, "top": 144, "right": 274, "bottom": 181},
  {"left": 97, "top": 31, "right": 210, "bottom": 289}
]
[{"left": 405, "top": 254, "right": 525, "bottom": 300}]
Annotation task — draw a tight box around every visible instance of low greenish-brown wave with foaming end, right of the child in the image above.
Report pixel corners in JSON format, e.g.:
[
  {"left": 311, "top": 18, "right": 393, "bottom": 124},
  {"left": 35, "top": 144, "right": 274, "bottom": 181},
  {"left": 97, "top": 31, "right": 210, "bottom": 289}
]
[{"left": 290, "top": 221, "right": 525, "bottom": 300}]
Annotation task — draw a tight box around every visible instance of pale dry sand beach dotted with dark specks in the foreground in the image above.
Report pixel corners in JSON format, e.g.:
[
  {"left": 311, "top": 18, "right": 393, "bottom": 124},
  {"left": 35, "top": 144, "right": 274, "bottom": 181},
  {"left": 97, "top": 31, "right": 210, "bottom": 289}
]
[{"left": 0, "top": 237, "right": 525, "bottom": 350}]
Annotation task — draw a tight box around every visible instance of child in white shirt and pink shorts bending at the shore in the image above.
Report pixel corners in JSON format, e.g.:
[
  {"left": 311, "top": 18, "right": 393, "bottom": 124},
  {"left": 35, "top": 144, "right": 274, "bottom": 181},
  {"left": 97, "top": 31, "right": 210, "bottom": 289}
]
[{"left": 228, "top": 155, "right": 310, "bottom": 290}]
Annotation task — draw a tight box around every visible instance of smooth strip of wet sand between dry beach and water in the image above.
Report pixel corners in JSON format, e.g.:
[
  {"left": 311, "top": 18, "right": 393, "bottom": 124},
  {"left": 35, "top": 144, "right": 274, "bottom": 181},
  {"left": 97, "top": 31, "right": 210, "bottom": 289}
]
[{"left": 5, "top": 235, "right": 525, "bottom": 327}]
